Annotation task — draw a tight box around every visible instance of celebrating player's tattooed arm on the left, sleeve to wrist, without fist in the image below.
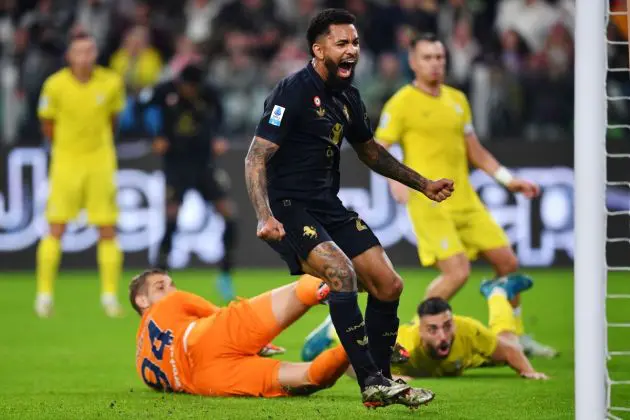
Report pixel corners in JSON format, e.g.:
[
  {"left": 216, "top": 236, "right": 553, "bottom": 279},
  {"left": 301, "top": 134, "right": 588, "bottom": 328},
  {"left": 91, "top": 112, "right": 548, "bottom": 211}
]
[{"left": 245, "top": 137, "right": 279, "bottom": 220}]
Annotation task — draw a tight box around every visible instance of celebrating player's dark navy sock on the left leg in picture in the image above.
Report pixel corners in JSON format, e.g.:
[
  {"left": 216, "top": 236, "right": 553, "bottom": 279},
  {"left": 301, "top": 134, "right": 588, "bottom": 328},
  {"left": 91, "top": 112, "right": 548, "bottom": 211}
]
[{"left": 328, "top": 292, "right": 378, "bottom": 389}]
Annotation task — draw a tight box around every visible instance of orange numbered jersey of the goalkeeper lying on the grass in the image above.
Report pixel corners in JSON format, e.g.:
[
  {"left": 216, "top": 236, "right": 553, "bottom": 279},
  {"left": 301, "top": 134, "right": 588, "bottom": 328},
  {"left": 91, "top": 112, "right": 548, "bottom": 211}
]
[{"left": 136, "top": 291, "right": 219, "bottom": 392}]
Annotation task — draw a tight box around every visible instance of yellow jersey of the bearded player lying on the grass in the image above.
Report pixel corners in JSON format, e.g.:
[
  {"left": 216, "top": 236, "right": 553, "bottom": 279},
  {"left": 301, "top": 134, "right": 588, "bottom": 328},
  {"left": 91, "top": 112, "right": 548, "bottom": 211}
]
[{"left": 392, "top": 315, "right": 497, "bottom": 377}]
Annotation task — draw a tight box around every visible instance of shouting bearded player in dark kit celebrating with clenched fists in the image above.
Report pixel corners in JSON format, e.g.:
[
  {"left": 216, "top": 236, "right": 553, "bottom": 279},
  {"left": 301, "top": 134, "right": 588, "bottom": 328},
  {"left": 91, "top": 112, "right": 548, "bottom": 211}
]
[{"left": 245, "top": 9, "right": 454, "bottom": 407}]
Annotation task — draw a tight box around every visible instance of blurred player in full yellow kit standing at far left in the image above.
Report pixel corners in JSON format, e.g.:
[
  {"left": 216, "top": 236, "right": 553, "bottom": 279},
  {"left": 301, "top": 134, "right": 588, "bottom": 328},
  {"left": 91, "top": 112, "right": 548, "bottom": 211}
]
[{"left": 35, "top": 34, "right": 125, "bottom": 317}]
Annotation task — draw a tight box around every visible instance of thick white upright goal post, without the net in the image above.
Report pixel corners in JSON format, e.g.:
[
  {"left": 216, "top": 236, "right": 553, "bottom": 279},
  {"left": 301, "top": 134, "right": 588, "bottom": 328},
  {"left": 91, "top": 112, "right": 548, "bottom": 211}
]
[{"left": 574, "top": 0, "right": 608, "bottom": 420}]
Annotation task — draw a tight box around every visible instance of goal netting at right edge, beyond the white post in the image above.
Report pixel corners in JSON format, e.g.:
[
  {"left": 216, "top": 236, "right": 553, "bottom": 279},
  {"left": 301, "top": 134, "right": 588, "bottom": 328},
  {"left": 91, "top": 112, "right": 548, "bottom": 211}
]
[{"left": 605, "top": 0, "right": 630, "bottom": 419}]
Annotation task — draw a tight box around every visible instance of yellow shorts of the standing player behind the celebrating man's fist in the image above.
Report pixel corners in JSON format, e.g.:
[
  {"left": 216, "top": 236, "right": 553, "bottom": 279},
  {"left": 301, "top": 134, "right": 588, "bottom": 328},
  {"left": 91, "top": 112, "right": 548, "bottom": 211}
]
[{"left": 407, "top": 201, "right": 510, "bottom": 266}]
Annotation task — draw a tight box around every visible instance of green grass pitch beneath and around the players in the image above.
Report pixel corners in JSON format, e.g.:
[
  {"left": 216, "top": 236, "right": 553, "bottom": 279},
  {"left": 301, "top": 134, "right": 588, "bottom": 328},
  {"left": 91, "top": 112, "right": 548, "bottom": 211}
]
[{"left": 0, "top": 270, "right": 630, "bottom": 419}]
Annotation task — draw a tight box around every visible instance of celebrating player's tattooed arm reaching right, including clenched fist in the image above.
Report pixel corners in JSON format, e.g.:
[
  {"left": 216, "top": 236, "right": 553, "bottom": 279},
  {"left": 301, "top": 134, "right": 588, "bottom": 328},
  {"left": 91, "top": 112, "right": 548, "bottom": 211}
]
[{"left": 352, "top": 139, "right": 453, "bottom": 201}]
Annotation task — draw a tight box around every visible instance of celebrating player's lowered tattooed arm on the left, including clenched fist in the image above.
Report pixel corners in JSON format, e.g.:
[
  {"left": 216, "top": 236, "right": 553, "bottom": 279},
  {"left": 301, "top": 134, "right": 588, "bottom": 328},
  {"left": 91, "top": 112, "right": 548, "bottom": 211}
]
[{"left": 245, "top": 137, "right": 284, "bottom": 240}]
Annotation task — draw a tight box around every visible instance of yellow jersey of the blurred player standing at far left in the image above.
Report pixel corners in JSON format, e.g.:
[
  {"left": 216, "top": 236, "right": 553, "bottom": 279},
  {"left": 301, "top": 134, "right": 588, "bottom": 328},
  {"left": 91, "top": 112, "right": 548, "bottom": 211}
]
[{"left": 38, "top": 67, "right": 125, "bottom": 164}]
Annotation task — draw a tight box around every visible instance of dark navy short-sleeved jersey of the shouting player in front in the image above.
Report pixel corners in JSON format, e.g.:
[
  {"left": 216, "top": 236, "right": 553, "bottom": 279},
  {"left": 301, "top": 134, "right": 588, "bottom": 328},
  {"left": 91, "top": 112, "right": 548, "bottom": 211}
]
[{"left": 256, "top": 63, "right": 373, "bottom": 201}]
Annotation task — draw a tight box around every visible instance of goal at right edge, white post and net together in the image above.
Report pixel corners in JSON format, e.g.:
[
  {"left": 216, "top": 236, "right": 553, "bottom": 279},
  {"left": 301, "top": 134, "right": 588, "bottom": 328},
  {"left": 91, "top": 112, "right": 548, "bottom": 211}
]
[{"left": 574, "top": 0, "right": 630, "bottom": 420}]
